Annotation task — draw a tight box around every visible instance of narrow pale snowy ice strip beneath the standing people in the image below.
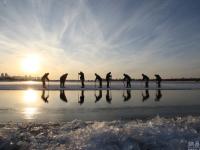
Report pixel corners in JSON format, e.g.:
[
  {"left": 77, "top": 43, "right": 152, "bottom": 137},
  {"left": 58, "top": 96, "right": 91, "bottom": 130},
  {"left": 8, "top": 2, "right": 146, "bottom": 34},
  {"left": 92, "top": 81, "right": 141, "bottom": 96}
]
[{"left": 0, "top": 81, "right": 200, "bottom": 90}]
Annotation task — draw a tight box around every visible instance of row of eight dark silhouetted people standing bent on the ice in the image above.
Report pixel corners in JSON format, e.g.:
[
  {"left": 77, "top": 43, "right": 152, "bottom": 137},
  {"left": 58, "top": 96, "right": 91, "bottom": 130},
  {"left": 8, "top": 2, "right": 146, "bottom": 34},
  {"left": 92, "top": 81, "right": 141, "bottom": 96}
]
[{"left": 41, "top": 71, "right": 162, "bottom": 88}]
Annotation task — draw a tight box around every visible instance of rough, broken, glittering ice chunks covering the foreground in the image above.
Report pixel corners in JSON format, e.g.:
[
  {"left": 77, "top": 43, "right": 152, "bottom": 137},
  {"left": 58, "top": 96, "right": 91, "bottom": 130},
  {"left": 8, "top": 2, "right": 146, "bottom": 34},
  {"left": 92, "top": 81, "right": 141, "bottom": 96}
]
[{"left": 0, "top": 116, "right": 200, "bottom": 150}]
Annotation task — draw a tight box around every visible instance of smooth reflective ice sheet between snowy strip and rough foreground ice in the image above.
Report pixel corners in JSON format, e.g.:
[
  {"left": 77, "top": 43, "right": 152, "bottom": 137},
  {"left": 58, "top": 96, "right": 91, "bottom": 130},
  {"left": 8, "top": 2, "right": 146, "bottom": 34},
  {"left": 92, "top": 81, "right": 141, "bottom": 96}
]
[{"left": 0, "top": 90, "right": 200, "bottom": 123}]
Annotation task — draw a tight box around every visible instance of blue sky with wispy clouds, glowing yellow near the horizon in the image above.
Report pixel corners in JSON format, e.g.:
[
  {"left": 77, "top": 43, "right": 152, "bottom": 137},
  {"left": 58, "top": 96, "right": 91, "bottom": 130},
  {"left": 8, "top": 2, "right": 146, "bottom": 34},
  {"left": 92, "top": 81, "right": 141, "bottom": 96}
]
[{"left": 0, "top": 0, "right": 200, "bottom": 79}]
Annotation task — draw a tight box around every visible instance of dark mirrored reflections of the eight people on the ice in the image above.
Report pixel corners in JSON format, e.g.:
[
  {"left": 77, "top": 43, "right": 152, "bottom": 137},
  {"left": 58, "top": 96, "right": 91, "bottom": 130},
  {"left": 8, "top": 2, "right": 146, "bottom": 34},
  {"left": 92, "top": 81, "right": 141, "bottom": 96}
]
[{"left": 41, "top": 89, "right": 162, "bottom": 105}]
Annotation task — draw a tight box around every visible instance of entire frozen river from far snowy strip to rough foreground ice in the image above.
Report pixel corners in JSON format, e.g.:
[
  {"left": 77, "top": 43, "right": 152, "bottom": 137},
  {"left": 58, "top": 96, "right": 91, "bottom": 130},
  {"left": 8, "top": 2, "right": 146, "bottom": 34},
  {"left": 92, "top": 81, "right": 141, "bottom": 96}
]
[{"left": 0, "top": 82, "right": 200, "bottom": 150}]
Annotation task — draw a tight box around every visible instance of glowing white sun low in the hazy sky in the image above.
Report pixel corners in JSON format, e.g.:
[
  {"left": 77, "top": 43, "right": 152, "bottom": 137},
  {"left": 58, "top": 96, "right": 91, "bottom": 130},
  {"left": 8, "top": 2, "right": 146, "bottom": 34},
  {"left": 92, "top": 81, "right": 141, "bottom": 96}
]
[{"left": 21, "top": 55, "right": 40, "bottom": 73}]
